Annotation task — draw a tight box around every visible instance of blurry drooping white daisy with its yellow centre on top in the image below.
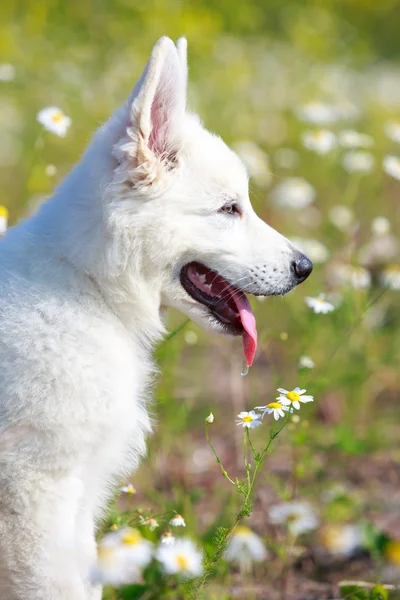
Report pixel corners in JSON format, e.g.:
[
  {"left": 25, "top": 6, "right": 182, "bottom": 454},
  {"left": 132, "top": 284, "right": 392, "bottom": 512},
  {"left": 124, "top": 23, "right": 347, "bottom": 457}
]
[{"left": 224, "top": 525, "right": 268, "bottom": 570}]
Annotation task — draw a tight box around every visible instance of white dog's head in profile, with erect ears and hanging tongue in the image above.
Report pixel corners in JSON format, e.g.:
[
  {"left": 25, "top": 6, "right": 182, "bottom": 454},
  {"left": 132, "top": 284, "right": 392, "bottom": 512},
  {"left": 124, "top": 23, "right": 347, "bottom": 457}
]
[{"left": 104, "top": 38, "right": 312, "bottom": 364}]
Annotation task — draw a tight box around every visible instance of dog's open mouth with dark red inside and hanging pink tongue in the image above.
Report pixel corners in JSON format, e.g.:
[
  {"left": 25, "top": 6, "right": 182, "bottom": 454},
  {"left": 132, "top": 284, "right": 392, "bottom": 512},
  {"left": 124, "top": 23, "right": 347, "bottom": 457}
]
[{"left": 180, "top": 262, "right": 257, "bottom": 366}]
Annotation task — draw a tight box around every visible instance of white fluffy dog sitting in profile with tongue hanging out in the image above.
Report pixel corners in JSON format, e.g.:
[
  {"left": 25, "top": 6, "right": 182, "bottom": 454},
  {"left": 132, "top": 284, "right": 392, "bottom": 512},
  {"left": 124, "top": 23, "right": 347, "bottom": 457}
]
[{"left": 0, "top": 38, "right": 312, "bottom": 600}]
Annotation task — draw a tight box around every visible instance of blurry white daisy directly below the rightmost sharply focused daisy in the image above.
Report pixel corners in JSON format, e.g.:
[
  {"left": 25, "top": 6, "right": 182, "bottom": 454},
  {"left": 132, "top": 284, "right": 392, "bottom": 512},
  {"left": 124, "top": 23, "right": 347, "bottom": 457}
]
[{"left": 268, "top": 501, "right": 319, "bottom": 535}]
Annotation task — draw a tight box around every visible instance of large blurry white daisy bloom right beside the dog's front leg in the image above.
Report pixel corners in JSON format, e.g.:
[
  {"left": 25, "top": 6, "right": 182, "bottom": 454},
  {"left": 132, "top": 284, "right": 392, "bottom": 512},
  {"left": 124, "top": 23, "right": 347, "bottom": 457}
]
[{"left": 92, "top": 527, "right": 153, "bottom": 585}]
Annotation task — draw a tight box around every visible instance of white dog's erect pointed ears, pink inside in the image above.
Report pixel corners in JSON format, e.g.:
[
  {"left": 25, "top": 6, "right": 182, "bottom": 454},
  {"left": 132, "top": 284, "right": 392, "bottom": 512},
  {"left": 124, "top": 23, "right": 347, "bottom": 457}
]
[{"left": 127, "top": 37, "right": 187, "bottom": 168}]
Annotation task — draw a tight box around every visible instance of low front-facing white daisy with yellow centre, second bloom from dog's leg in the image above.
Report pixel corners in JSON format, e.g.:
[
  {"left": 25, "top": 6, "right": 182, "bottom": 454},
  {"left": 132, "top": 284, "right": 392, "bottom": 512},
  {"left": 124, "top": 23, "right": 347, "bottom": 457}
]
[{"left": 156, "top": 538, "right": 203, "bottom": 577}]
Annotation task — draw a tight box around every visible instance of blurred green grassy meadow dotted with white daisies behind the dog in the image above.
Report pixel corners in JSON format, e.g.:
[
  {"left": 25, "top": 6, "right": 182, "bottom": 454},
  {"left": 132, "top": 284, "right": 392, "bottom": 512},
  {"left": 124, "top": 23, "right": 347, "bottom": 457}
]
[{"left": 0, "top": 0, "right": 400, "bottom": 600}]
